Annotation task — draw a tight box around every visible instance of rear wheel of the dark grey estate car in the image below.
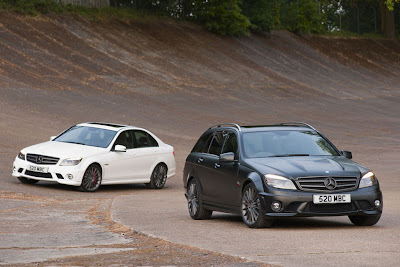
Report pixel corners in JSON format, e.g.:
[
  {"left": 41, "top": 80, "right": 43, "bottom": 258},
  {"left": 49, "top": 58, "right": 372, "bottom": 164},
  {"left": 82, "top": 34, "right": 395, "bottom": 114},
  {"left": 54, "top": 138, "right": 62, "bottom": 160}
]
[{"left": 187, "top": 179, "right": 213, "bottom": 220}]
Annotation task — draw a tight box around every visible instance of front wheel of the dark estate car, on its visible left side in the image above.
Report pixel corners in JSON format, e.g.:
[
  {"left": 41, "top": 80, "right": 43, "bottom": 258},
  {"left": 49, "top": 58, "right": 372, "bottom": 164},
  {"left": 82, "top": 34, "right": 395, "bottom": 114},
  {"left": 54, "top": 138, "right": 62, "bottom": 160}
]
[{"left": 241, "top": 183, "right": 273, "bottom": 228}]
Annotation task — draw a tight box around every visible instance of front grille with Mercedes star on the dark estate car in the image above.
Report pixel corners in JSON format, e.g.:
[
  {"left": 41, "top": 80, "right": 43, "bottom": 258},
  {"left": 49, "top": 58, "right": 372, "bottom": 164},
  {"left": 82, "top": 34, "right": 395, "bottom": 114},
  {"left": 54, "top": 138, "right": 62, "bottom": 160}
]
[{"left": 297, "top": 176, "right": 358, "bottom": 192}]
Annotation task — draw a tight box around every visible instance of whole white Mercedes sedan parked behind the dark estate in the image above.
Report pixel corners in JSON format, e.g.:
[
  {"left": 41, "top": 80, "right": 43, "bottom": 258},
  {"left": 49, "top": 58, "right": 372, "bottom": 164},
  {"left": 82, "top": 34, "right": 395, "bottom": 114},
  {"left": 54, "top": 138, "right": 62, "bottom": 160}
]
[{"left": 12, "top": 122, "right": 176, "bottom": 192}]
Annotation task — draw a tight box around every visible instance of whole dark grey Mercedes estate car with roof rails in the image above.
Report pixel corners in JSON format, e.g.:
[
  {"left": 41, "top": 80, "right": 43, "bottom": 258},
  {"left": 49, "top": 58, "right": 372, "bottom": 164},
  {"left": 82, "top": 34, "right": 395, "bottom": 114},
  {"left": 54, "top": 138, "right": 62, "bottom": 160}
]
[{"left": 183, "top": 122, "right": 382, "bottom": 228}]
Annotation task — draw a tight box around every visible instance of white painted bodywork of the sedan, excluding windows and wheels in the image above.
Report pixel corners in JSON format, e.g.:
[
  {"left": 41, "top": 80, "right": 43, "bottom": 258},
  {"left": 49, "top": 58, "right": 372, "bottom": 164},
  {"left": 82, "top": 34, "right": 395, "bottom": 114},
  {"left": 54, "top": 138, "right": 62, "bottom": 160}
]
[{"left": 12, "top": 123, "right": 176, "bottom": 189}]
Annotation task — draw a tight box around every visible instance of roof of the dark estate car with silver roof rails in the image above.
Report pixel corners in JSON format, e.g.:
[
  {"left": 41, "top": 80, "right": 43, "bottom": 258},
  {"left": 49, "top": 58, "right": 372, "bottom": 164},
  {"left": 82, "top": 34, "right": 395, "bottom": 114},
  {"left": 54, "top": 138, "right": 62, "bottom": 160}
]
[{"left": 209, "top": 122, "right": 317, "bottom": 132}]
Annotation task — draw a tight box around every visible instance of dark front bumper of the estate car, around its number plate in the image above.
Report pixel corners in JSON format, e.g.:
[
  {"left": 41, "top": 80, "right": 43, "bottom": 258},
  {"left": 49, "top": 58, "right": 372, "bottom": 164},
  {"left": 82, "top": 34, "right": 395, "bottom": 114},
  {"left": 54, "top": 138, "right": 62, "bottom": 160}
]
[{"left": 260, "top": 186, "right": 383, "bottom": 217}]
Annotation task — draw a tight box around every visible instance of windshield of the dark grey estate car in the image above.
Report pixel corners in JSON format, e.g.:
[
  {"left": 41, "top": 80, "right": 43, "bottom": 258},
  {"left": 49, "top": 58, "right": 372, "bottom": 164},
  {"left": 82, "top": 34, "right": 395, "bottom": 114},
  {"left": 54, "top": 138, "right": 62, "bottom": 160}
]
[{"left": 243, "top": 130, "right": 339, "bottom": 158}]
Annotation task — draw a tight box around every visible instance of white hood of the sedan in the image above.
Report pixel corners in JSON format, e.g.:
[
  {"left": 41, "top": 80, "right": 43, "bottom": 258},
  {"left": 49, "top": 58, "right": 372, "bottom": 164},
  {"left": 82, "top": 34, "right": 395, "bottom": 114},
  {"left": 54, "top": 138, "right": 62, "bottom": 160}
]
[{"left": 22, "top": 141, "right": 107, "bottom": 159}]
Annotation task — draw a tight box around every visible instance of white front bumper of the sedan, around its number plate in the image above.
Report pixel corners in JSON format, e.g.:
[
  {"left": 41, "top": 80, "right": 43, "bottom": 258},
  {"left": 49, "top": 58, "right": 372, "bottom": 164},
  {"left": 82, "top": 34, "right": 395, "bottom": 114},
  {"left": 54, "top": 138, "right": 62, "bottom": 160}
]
[{"left": 12, "top": 158, "right": 84, "bottom": 186}]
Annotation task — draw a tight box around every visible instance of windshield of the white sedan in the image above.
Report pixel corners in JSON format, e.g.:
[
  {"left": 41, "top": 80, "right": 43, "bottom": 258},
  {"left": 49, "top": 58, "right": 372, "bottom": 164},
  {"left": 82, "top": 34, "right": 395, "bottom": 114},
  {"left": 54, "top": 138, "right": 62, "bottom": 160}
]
[{"left": 53, "top": 126, "right": 117, "bottom": 148}]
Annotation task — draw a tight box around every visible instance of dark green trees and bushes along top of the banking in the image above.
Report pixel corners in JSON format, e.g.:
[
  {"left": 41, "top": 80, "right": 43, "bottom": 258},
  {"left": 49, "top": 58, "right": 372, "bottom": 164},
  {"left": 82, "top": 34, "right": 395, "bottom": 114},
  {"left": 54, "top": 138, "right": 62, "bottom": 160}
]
[{"left": 0, "top": 0, "right": 400, "bottom": 36}]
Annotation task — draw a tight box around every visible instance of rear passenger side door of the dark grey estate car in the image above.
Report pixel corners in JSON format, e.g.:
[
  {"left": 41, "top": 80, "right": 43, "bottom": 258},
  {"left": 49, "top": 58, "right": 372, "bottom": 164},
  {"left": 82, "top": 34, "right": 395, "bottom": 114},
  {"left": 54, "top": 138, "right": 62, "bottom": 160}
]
[{"left": 196, "top": 131, "right": 226, "bottom": 203}]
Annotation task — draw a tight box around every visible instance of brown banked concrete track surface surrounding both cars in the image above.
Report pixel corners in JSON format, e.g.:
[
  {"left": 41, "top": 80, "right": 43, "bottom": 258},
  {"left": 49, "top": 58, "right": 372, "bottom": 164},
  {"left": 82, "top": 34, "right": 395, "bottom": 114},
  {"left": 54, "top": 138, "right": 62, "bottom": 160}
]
[{"left": 0, "top": 12, "right": 400, "bottom": 266}]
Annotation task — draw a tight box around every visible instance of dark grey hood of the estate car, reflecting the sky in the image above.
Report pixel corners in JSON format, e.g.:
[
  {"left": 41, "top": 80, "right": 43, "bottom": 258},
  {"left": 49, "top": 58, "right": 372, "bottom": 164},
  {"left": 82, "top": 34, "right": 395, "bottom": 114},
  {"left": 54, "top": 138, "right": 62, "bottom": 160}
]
[{"left": 245, "top": 156, "right": 368, "bottom": 179}]
